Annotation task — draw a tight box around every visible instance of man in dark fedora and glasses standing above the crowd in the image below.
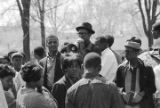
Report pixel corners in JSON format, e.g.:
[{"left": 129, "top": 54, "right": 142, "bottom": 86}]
[{"left": 76, "top": 22, "right": 95, "bottom": 58}]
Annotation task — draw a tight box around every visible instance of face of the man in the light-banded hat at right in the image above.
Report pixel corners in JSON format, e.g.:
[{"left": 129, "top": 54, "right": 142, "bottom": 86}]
[{"left": 125, "top": 47, "right": 137, "bottom": 61}]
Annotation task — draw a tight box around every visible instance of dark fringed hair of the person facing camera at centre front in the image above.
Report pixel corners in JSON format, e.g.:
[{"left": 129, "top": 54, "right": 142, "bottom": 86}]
[{"left": 62, "top": 54, "right": 82, "bottom": 73}]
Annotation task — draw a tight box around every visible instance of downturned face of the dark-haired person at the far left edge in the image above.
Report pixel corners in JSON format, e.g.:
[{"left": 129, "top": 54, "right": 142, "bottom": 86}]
[{"left": 1, "top": 76, "right": 13, "bottom": 91}]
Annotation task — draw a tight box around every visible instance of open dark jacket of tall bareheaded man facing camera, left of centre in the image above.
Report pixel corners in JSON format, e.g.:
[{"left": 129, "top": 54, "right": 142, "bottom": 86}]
[{"left": 39, "top": 52, "right": 64, "bottom": 91}]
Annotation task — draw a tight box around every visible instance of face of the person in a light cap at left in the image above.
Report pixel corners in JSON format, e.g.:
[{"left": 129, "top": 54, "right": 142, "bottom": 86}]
[{"left": 11, "top": 57, "right": 23, "bottom": 68}]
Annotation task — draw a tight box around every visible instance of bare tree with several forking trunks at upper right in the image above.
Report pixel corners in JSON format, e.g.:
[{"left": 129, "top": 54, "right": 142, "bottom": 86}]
[{"left": 138, "top": 0, "right": 160, "bottom": 48}]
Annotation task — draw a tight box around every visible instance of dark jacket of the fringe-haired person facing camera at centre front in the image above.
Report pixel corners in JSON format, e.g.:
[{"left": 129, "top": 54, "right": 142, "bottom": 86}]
[{"left": 51, "top": 76, "right": 71, "bottom": 108}]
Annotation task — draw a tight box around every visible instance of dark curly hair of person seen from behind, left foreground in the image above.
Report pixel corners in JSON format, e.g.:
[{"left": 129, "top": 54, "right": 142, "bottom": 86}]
[{"left": 21, "top": 62, "right": 43, "bottom": 82}]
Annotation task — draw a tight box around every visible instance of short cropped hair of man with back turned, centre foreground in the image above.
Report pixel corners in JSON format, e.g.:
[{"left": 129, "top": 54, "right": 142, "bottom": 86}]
[{"left": 83, "top": 52, "right": 101, "bottom": 68}]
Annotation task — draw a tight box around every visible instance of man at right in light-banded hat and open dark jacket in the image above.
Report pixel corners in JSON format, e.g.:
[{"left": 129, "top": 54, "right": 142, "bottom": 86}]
[{"left": 115, "top": 38, "right": 156, "bottom": 108}]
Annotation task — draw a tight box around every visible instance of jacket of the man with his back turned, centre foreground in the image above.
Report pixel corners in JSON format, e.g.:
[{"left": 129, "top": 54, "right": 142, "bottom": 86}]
[{"left": 65, "top": 76, "right": 124, "bottom": 108}]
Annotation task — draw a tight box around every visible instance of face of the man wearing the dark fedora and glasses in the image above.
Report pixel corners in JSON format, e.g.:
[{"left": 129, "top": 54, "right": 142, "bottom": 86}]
[{"left": 78, "top": 29, "right": 91, "bottom": 41}]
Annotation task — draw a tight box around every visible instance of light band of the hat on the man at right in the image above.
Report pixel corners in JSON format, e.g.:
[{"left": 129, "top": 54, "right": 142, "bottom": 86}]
[{"left": 124, "top": 41, "right": 141, "bottom": 50}]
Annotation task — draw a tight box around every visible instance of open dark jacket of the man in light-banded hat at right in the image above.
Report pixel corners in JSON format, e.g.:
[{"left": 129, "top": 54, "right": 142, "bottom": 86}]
[{"left": 115, "top": 59, "right": 156, "bottom": 108}]
